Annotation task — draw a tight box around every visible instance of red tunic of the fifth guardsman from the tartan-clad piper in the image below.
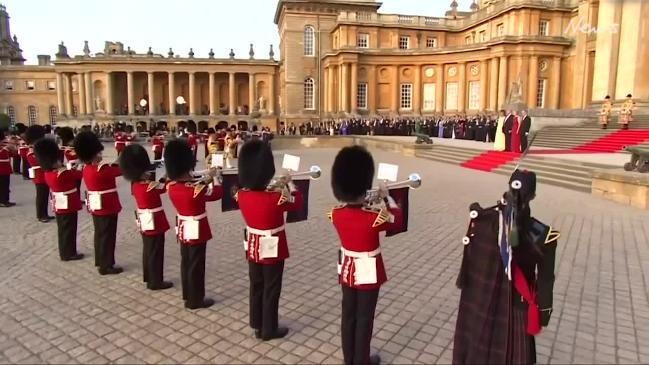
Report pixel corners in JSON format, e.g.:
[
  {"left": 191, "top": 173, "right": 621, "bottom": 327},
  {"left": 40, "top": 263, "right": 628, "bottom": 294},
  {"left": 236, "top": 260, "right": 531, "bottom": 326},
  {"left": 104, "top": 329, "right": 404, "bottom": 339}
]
[{"left": 83, "top": 163, "right": 122, "bottom": 216}]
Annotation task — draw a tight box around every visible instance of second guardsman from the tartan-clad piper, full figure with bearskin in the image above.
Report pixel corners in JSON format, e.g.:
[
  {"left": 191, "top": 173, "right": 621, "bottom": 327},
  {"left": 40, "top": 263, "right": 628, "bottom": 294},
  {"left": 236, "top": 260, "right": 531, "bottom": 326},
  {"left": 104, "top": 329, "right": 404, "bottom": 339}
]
[{"left": 236, "top": 141, "right": 302, "bottom": 341}]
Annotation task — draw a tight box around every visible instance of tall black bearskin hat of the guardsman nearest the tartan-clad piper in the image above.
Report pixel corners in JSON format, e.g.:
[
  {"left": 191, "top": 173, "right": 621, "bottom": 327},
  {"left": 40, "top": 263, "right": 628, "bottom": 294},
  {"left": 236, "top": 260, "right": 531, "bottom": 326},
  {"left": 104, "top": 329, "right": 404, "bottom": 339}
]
[{"left": 331, "top": 146, "right": 374, "bottom": 203}]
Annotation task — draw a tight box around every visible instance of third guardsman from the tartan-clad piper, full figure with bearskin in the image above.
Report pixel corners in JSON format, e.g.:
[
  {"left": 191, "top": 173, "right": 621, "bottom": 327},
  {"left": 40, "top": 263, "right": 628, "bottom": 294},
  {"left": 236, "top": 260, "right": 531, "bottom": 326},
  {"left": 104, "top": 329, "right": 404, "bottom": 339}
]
[{"left": 164, "top": 140, "right": 223, "bottom": 309}]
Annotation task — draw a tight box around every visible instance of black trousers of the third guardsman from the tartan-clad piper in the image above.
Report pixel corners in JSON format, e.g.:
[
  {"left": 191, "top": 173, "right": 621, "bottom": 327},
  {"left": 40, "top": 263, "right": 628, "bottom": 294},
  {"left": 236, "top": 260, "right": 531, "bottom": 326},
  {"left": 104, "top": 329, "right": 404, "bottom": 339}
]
[{"left": 180, "top": 242, "right": 207, "bottom": 307}]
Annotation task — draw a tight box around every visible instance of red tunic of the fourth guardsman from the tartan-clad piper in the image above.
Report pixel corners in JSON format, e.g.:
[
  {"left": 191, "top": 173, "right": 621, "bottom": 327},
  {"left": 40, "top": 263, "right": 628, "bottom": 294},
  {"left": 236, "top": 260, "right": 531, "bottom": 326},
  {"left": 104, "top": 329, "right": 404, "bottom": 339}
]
[{"left": 131, "top": 181, "right": 169, "bottom": 236}]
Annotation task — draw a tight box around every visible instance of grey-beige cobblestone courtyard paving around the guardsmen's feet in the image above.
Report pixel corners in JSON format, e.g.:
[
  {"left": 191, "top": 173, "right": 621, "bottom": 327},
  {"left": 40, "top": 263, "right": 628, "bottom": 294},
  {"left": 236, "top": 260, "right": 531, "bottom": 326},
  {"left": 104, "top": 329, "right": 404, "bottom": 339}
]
[{"left": 0, "top": 145, "right": 649, "bottom": 363}]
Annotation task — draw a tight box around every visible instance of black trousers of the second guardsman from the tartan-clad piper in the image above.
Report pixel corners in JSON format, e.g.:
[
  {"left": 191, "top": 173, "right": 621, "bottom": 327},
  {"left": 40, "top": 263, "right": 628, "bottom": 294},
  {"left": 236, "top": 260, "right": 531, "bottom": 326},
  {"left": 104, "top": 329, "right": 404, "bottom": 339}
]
[{"left": 248, "top": 261, "right": 284, "bottom": 337}]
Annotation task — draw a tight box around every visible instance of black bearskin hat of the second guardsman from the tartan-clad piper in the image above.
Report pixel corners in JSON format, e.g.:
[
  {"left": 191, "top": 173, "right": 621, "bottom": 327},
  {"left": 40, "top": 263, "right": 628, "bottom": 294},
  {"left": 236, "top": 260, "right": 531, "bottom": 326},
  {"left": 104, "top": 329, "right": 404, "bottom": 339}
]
[{"left": 239, "top": 141, "right": 275, "bottom": 190}]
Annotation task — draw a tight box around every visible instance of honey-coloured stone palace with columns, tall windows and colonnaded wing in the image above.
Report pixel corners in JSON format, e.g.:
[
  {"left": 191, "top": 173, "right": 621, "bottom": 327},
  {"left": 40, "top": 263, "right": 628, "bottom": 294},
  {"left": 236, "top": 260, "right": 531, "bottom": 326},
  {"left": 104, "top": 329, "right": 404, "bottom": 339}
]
[{"left": 0, "top": 0, "right": 649, "bottom": 129}]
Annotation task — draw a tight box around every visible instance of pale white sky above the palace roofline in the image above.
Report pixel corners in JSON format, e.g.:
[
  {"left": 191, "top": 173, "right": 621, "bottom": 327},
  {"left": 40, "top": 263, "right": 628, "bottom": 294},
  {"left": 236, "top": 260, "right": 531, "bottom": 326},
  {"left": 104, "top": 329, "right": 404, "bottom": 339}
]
[{"left": 0, "top": 0, "right": 472, "bottom": 64}]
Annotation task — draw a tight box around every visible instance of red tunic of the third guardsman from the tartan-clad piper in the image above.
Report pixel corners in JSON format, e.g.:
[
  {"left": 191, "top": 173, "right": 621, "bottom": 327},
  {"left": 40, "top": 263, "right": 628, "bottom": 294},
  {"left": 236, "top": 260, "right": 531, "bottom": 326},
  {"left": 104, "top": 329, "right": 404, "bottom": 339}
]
[{"left": 167, "top": 181, "right": 223, "bottom": 245}]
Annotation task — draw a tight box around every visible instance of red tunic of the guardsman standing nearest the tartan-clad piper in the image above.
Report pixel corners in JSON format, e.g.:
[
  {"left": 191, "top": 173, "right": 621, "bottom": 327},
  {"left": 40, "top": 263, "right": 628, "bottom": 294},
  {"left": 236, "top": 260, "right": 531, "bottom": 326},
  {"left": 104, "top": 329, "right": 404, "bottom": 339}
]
[{"left": 330, "top": 205, "right": 402, "bottom": 290}]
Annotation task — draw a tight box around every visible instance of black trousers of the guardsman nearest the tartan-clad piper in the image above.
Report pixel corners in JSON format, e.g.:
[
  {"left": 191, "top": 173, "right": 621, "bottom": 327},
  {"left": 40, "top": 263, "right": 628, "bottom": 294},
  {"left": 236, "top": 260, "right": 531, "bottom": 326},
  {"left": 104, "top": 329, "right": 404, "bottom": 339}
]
[{"left": 340, "top": 285, "right": 379, "bottom": 364}]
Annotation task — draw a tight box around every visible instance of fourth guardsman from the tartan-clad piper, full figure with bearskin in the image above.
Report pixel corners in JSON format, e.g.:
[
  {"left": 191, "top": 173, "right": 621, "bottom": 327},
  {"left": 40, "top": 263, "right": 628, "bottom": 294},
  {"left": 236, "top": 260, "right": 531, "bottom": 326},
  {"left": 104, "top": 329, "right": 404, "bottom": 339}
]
[{"left": 119, "top": 144, "right": 173, "bottom": 290}]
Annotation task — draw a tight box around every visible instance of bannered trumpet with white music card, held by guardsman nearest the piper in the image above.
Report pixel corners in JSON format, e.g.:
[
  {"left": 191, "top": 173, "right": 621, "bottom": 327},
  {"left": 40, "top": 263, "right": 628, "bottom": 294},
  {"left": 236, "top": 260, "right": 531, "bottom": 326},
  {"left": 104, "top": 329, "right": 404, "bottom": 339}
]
[{"left": 364, "top": 164, "right": 422, "bottom": 237}]
